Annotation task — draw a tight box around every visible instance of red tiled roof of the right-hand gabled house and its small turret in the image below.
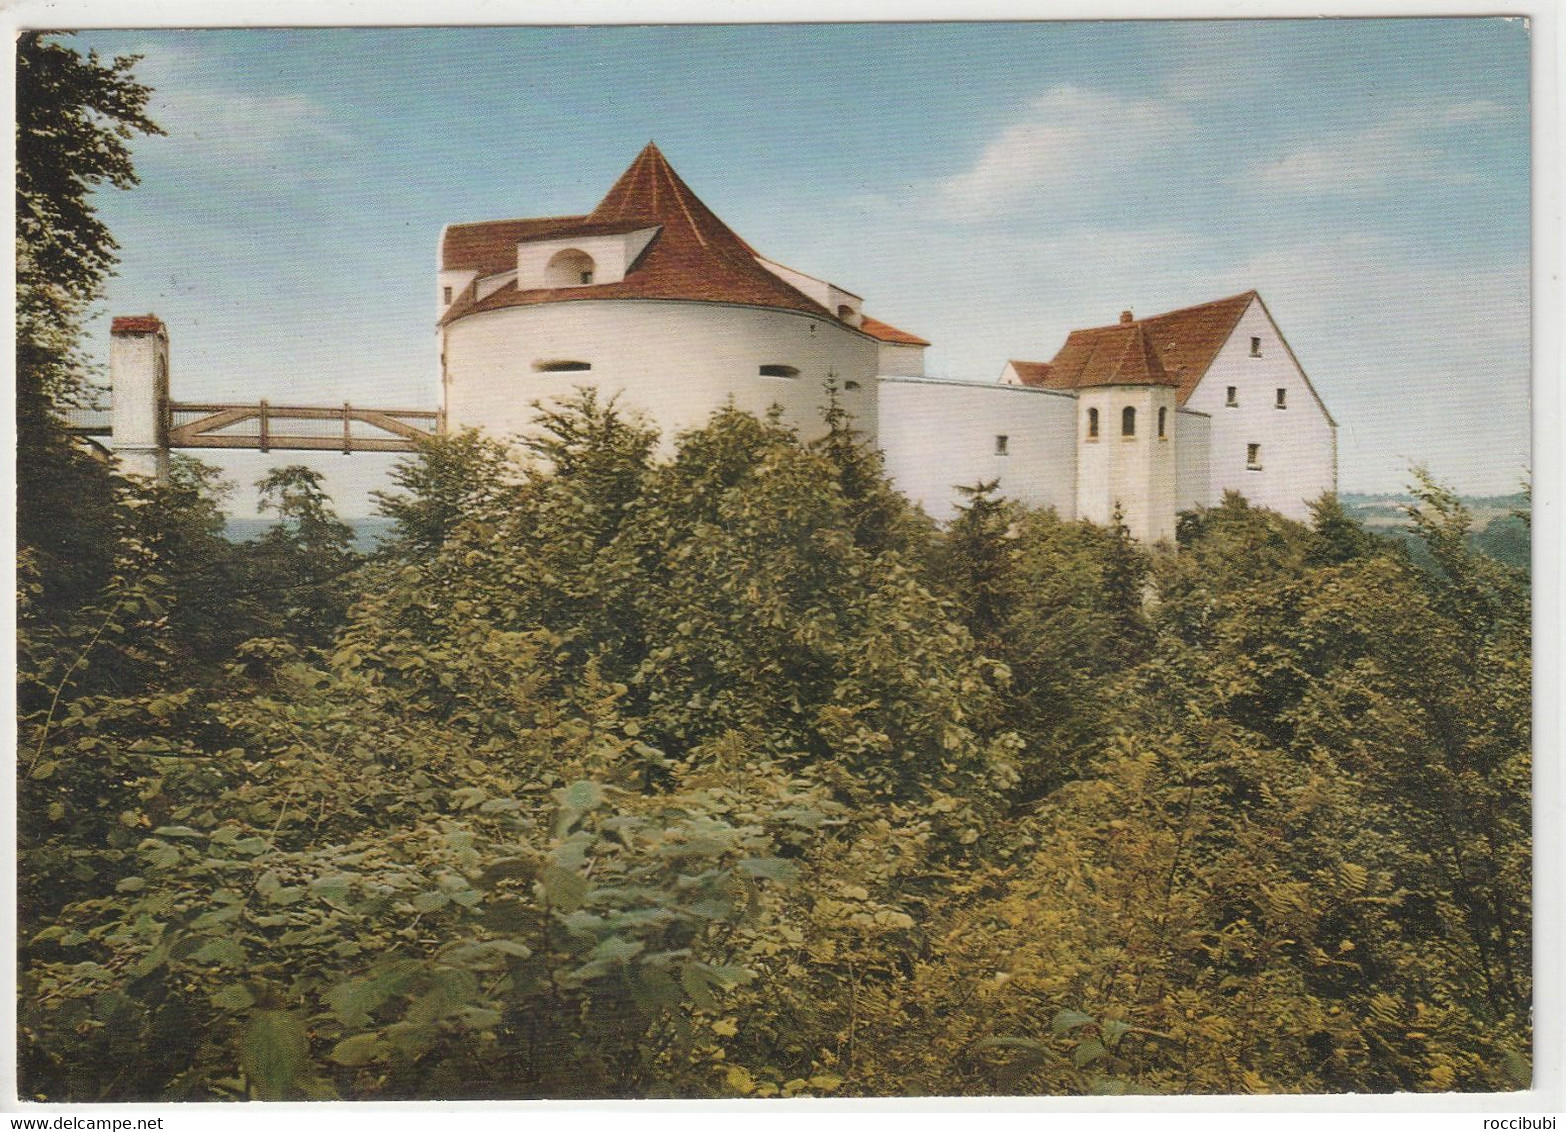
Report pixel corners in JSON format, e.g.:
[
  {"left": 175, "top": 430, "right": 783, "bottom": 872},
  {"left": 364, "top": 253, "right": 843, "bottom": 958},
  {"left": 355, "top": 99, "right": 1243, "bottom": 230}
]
[{"left": 1023, "top": 291, "right": 1257, "bottom": 404}]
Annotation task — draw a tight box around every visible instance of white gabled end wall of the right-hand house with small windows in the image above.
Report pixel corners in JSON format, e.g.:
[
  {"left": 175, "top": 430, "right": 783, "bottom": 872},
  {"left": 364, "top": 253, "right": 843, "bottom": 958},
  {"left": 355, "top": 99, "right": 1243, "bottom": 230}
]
[{"left": 1185, "top": 299, "right": 1337, "bottom": 520}]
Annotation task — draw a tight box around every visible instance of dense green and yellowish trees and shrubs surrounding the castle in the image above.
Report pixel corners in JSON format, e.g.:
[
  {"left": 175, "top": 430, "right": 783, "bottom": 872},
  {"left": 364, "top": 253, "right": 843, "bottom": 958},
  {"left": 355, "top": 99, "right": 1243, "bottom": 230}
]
[{"left": 17, "top": 38, "right": 1532, "bottom": 1102}]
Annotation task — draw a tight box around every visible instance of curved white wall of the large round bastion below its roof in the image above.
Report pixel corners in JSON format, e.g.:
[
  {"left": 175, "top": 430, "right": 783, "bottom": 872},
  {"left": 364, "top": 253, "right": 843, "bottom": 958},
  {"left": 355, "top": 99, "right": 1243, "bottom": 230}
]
[{"left": 443, "top": 299, "right": 877, "bottom": 451}]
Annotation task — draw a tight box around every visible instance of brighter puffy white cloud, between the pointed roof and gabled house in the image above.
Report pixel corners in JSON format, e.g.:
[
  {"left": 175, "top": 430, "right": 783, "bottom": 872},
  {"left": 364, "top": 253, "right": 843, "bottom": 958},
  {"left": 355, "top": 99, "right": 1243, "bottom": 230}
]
[{"left": 940, "top": 86, "right": 1192, "bottom": 221}]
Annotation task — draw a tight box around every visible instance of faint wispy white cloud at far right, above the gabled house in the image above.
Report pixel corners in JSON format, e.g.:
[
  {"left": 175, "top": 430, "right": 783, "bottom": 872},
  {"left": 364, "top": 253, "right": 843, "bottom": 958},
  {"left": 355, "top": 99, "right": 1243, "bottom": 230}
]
[{"left": 1251, "top": 99, "right": 1503, "bottom": 196}]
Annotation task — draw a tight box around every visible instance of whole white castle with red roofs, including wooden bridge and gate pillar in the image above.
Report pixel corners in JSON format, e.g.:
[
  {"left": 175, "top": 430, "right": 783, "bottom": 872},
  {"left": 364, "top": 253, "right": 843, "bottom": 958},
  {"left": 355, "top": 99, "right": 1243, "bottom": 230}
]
[{"left": 110, "top": 144, "right": 1337, "bottom": 542}]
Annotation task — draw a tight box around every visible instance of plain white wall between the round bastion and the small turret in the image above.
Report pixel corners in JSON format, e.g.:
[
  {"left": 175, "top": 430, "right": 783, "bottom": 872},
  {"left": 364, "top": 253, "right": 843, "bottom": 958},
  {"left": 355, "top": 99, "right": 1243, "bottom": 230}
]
[{"left": 880, "top": 376, "right": 1076, "bottom": 520}]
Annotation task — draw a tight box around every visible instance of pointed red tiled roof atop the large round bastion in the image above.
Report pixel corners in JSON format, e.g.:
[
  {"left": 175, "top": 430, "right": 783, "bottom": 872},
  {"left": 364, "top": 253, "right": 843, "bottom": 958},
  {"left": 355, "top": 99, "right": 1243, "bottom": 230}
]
[{"left": 440, "top": 142, "right": 929, "bottom": 344}]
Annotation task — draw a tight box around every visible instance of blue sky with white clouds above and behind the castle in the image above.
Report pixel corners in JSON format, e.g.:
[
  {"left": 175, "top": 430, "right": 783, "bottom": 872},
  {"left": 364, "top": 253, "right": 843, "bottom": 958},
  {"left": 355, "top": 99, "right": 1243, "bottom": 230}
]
[{"left": 75, "top": 19, "right": 1530, "bottom": 515}]
